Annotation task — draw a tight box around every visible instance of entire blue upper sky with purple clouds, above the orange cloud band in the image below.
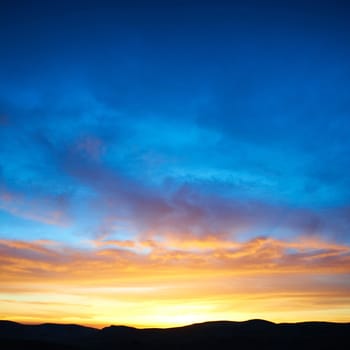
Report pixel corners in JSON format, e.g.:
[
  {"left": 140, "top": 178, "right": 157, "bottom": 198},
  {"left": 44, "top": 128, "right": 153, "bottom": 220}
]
[{"left": 0, "top": 1, "right": 350, "bottom": 243}]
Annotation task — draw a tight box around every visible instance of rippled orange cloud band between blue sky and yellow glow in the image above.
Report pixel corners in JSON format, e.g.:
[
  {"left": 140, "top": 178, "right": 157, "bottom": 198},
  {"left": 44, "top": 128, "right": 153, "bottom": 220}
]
[{"left": 0, "top": 236, "right": 350, "bottom": 284}]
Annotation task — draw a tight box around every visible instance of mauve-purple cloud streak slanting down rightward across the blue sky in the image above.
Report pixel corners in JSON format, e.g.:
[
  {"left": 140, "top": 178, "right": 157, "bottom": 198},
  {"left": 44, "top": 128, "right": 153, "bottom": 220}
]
[{"left": 32, "top": 131, "right": 350, "bottom": 240}]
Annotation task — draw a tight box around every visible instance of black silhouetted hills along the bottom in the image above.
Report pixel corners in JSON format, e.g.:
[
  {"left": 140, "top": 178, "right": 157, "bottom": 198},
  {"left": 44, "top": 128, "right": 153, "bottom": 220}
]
[{"left": 0, "top": 320, "right": 350, "bottom": 350}]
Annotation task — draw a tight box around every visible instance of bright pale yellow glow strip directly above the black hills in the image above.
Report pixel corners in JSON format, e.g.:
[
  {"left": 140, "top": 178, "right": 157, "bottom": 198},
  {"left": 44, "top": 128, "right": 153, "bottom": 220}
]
[{"left": 1, "top": 288, "right": 350, "bottom": 328}]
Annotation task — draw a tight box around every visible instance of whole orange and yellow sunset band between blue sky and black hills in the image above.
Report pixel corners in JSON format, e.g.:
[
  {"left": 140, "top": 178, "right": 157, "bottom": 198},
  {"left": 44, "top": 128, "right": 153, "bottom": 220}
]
[{"left": 0, "top": 237, "right": 350, "bottom": 327}]
